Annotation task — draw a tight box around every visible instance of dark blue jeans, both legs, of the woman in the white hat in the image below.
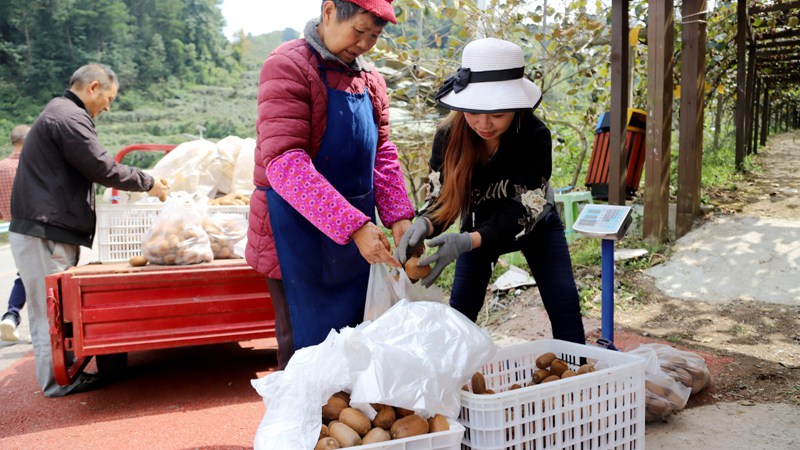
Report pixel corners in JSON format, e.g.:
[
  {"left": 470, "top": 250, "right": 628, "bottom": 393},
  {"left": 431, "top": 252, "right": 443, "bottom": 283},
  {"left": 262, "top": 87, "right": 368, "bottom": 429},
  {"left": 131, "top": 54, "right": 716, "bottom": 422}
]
[{"left": 450, "top": 209, "right": 586, "bottom": 344}]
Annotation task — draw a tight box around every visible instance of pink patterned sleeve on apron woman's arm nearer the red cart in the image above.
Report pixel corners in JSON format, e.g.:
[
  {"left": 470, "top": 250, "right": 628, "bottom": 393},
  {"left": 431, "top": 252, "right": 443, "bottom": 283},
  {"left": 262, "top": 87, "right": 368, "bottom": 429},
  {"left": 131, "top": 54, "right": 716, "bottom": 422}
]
[{"left": 266, "top": 150, "right": 369, "bottom": 245}]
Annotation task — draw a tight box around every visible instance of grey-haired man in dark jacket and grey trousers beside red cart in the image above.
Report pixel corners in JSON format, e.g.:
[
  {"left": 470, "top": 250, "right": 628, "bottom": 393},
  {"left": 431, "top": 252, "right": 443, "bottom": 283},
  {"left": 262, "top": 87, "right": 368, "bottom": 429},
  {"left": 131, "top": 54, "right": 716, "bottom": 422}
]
[{"left": 9, "top": 64, "right": 168, "bottom": 397}]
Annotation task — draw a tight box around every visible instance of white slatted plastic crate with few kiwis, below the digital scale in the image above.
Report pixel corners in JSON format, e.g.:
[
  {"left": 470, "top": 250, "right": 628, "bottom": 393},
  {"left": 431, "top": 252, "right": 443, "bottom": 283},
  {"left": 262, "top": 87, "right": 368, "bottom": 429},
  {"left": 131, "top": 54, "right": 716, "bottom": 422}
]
[{"left": 459, "top": 339, "right": 645, "bottom": 450}]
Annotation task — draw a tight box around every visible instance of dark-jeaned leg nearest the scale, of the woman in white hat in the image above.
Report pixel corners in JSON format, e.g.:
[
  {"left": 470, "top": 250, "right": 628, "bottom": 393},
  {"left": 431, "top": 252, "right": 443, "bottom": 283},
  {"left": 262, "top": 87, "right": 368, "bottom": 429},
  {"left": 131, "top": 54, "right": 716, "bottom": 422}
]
[{"left": 522, "top": 211, "right": 586, "bottom": 344}]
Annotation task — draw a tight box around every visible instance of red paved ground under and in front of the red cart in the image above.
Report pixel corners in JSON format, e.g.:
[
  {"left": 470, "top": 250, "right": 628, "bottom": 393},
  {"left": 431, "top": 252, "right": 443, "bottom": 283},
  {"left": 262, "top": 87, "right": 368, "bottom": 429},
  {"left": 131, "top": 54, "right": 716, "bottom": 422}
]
[{"left": 0, "top": 339, "right": 276, "bottom": 450}]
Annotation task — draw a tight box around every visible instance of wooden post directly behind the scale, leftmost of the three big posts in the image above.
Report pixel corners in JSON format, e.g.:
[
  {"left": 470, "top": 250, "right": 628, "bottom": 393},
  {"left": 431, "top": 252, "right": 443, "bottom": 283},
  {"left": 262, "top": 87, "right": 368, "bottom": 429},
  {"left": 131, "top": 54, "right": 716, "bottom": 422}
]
[{"left": 608, "top": 0, "right": 630, "bottom": 205}]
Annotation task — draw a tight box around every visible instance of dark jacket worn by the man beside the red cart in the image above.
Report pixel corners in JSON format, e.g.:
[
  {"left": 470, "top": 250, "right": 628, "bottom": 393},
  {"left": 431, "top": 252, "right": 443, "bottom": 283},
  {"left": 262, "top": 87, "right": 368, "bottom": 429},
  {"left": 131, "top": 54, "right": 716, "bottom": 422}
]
[{"left": 9, "top": 91, "right": 153, "bottom": 247}]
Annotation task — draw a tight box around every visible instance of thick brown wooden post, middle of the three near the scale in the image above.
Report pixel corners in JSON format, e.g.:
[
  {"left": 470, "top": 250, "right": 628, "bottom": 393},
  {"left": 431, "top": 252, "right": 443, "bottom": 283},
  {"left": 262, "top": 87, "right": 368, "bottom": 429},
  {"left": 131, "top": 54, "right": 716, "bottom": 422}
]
[{"left": 642, "top": 0, "right": 675, "bottom": 241}]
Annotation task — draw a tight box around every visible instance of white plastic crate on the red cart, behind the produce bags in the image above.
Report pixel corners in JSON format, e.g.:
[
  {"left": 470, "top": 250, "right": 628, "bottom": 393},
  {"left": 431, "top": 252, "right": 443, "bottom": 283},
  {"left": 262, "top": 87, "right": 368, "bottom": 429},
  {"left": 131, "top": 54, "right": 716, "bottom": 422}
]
[{"left": 95, "top": 203, "right": 250, "bottom": 262}]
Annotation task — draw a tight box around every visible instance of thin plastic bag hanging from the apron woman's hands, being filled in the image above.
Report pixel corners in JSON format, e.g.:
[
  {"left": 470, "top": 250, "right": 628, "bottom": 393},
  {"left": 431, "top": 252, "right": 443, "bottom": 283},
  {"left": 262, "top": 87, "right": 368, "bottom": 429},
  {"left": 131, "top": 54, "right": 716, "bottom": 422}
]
[{"left": 364, "top": 263, "right": 444, "bottom": 320}]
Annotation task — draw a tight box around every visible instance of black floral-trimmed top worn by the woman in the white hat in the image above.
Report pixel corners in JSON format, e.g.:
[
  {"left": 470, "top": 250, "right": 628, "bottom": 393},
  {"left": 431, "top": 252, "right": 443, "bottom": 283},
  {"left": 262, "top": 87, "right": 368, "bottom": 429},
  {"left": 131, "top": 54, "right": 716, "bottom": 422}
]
[{"left": 421, "top": 114, "right": 553, "bottom": 253}]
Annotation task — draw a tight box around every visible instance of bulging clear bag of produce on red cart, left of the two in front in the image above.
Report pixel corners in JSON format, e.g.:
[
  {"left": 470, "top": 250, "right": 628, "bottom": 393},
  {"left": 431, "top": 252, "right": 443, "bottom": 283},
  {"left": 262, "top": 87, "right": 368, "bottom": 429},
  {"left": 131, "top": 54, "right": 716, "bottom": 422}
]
[{"left": 142, "top": 193, "right": 214, "bottom": 265}]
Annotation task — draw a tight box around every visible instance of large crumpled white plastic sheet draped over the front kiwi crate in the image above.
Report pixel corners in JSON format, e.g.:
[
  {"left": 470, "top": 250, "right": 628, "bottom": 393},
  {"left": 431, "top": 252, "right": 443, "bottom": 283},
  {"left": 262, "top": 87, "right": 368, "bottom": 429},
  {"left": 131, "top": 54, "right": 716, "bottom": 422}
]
[{"left": 251, "top": 300, "right": 497, "bottom": 450}]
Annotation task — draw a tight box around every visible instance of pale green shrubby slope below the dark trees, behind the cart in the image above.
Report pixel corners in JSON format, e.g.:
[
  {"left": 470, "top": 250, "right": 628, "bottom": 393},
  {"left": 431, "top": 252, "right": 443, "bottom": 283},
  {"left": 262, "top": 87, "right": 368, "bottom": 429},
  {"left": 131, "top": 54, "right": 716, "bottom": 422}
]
[{"left": 0, "top": 29, "right": 300, "bottom": 168}]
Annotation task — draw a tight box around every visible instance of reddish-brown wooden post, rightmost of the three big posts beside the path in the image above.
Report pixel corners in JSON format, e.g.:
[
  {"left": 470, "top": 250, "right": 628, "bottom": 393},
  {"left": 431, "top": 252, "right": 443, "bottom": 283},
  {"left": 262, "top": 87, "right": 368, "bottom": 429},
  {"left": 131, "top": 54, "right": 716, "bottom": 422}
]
[{"left": 675, "top": 0, "right": 706, "bottom": 237}]
